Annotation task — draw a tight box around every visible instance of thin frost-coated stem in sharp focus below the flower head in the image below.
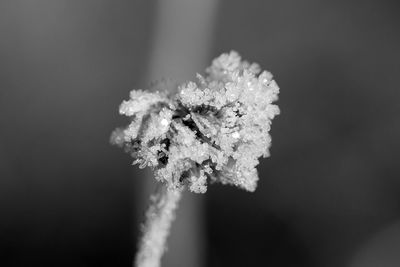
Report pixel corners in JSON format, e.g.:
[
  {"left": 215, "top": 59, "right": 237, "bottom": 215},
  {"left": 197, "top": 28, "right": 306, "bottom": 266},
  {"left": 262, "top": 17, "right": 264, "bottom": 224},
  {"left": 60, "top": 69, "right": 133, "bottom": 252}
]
[{"left": 135, "top": 185, "right": 182, "bottom": 267}]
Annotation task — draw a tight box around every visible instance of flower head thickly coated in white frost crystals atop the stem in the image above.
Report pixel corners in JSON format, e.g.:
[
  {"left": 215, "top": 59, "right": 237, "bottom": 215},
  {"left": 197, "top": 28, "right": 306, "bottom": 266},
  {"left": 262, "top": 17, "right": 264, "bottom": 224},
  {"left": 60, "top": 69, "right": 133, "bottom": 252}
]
[{"left": 111, "top": 51, "right": 279, "bottom": 193}]
